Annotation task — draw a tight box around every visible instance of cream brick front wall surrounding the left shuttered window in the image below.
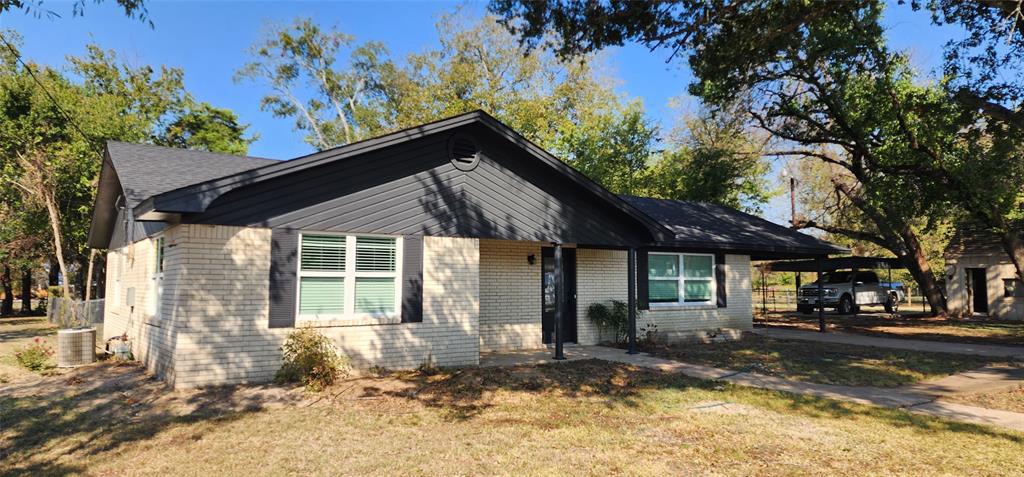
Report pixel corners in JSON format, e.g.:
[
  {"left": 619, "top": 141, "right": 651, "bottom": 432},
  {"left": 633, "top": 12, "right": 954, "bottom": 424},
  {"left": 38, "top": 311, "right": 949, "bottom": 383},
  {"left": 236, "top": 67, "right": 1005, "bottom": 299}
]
[{"left": 126, "top": 225, "right": 479, "bottom": 387}]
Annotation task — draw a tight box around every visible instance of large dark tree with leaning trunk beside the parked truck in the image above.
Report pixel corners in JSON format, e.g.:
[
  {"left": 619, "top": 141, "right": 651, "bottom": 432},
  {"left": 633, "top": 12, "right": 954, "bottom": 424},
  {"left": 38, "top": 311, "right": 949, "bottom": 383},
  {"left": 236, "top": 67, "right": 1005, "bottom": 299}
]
[{"left": 492, "top": 0, "right": 958, "bottom": 312}]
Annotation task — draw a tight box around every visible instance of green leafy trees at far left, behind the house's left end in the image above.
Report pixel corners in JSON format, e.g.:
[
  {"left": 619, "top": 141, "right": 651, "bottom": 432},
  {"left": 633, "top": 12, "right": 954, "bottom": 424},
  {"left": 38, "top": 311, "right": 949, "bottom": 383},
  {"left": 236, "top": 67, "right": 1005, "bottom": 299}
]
[{"left": 0, "top": 37, "right": 249, "bottom": 300}]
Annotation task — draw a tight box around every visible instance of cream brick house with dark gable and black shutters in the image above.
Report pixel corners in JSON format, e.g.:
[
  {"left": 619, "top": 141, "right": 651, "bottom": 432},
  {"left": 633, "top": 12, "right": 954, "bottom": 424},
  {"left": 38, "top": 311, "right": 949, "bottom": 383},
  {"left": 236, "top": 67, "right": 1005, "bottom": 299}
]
[{"left": 89, "top": 112, "right": 845, "bottom": 387}]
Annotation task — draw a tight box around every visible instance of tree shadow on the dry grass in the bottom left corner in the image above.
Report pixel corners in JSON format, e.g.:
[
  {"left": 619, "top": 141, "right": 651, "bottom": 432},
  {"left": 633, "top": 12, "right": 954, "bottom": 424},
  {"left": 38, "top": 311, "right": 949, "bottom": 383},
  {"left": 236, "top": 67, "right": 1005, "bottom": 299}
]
[{"left": 0, "top": 363, "right": 284, "bottom": 476}]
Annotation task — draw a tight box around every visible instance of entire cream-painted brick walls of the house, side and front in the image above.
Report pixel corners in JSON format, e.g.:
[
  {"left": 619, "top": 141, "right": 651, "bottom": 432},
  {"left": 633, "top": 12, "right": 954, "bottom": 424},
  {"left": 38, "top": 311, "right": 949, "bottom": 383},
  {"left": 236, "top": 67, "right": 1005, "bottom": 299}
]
[{"left": 103, "top": 224, "right": 752, "bottom": 387}]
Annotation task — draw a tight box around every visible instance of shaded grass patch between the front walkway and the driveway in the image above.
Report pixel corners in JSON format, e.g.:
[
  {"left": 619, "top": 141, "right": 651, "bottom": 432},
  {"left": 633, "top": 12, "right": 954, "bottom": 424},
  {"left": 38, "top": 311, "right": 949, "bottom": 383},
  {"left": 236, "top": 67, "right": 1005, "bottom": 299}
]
[{"left": 647, "top": 334, "right": 989, "bottom": 388}]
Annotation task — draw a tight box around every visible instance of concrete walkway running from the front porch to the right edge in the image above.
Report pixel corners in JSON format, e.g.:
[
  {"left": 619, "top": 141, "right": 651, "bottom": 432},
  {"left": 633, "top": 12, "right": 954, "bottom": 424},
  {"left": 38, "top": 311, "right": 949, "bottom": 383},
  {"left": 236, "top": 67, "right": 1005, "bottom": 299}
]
[{"left": 480, "top": 346, "right": 1024, "bottom": 432}]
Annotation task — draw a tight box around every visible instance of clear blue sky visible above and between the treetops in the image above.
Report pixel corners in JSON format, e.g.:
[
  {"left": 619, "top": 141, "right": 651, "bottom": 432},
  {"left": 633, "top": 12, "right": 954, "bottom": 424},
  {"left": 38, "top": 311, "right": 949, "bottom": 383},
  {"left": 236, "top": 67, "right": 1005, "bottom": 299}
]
[{"left": 0, "top": 1, "right": 959, "bottom": 222}]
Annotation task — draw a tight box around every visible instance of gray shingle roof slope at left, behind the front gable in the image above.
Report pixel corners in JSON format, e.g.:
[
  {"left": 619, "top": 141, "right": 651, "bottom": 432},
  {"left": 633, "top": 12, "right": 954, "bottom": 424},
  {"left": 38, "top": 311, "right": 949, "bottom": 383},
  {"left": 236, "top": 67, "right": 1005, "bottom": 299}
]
[{"left": 106, "top": 141, "right": 279, "bottom": 208}]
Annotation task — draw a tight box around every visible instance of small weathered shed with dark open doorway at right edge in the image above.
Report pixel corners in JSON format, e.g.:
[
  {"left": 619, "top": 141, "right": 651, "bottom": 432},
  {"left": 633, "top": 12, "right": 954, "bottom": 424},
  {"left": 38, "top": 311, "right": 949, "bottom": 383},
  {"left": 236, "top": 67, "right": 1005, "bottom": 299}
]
[{"left": 945, "top": 226, "right": 1024, "bottom": 319}]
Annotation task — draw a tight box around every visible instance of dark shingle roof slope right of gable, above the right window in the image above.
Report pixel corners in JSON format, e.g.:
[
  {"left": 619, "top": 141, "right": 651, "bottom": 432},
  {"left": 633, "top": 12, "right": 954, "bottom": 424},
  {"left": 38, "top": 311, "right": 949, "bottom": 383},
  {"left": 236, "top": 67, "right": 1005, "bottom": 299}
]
[{"left": 621, "top": 196, "right": 849, "bottom": 258}]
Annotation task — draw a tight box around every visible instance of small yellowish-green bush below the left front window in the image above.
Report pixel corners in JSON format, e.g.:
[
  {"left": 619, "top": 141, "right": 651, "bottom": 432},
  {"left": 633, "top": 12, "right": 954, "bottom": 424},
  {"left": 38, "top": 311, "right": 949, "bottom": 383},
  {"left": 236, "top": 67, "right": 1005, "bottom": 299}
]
[{"left": 274, "top": 328, "right": 348, "bottom": 391}]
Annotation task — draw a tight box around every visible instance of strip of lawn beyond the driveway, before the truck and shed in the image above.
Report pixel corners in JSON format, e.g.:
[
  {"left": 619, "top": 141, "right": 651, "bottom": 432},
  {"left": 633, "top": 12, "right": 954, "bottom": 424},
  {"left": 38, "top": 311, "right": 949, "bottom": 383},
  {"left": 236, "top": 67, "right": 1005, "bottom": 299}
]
[{"left": 755, "top": 313, "right": 1024, "bottom": 346}]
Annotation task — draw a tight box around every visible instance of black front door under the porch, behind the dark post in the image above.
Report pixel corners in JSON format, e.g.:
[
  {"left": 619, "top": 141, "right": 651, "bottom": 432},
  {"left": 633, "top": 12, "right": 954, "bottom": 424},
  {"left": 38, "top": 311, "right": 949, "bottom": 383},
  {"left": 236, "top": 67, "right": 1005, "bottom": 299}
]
[{"left": 541, "top": 248, "right": 577, "bottom": 344}]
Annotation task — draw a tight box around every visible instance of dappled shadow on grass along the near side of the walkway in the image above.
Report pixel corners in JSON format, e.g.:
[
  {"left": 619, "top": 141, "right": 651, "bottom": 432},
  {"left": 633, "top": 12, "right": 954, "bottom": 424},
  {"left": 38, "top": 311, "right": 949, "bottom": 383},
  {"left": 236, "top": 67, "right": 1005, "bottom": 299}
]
[{"left": 370, "top": 359, "right": 1024, "bottom": 443}]
